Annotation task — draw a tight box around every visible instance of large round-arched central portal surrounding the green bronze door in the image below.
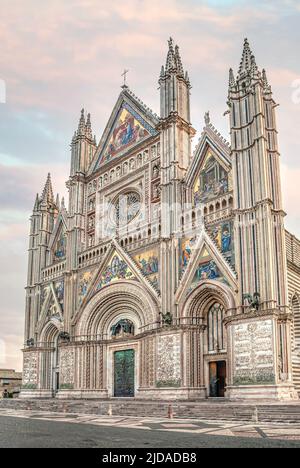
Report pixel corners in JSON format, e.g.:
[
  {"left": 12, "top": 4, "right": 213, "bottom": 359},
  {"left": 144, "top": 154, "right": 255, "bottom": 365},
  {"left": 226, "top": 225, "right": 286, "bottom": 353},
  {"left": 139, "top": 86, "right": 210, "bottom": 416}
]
[{"left": 73, "top": 281, "right": 159, "bottom": 398}]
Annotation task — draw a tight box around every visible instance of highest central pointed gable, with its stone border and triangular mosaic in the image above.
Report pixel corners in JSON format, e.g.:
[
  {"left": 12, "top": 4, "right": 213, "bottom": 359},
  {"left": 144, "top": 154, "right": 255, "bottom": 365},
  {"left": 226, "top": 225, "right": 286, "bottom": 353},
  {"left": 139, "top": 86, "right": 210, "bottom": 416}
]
[{"left": 92, "top": 87, "right": 158, "bottom": 171}]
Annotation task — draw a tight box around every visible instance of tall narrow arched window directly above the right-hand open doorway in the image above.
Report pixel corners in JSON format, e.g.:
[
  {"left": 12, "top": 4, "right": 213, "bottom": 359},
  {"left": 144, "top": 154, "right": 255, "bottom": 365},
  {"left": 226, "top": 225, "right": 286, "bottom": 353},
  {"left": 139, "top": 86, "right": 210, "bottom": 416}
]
[{"left": 207, "top": 302, "right": 226, "bottom": 353}]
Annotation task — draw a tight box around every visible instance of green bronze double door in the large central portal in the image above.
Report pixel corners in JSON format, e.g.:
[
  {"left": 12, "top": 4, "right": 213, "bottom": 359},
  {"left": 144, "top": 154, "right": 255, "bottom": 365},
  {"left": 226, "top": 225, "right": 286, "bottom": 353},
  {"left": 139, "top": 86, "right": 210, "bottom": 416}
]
[{"left": 114, "top": 349, "right": 135, "bottom": 398}]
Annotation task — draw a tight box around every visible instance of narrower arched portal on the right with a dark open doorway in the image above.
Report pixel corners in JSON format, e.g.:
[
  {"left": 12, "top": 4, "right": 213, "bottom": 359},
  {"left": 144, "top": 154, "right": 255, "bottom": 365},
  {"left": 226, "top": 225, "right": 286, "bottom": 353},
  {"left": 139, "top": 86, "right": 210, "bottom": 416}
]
[{"left": 181, "top": 280, "right": 235, "bottom": 398}]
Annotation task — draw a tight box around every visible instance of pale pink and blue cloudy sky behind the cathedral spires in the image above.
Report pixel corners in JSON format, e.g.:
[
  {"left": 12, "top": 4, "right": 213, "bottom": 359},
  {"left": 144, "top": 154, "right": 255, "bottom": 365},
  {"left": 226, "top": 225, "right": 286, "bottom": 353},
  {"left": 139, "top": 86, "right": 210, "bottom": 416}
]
[{"left": 0, "top": 0, "right": 300, "bottom": 370}]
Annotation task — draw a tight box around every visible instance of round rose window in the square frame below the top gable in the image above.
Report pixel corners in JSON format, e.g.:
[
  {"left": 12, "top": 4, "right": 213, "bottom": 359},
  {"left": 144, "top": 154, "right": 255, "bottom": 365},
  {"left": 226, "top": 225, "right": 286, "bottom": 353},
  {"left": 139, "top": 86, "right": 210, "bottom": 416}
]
[{"left": 110, "top": 191, "right": 141, "bottom": 226}]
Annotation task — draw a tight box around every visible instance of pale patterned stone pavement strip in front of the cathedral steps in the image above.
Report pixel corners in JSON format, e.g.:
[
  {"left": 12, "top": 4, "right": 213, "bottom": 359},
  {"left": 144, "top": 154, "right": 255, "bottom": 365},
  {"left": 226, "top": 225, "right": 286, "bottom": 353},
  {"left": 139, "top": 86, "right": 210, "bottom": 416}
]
[{"left": 0, "top": 409, "right": 300, "bottom": 447}]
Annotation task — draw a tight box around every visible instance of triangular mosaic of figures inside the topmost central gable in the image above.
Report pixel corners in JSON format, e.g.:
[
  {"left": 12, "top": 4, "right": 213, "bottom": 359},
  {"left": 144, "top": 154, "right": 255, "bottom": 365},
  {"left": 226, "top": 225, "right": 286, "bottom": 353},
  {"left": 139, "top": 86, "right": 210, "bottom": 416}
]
[{"left": 101, "top": 103, "right": 156, "bottom": 163}]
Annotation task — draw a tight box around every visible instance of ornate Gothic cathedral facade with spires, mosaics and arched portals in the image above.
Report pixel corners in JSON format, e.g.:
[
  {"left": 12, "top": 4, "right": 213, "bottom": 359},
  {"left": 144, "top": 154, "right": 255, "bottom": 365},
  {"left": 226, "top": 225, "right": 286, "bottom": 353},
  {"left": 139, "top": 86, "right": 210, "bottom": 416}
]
[{"left": 21, "top": 40, "right": 300, "bottom": 400}]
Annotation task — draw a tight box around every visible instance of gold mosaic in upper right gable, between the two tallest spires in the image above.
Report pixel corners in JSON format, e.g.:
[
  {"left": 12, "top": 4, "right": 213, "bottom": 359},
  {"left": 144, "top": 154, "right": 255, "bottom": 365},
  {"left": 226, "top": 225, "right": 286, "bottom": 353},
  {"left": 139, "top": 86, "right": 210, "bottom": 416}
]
[{"left": 194, "top": 155, "right": 230, "bottom": 205}]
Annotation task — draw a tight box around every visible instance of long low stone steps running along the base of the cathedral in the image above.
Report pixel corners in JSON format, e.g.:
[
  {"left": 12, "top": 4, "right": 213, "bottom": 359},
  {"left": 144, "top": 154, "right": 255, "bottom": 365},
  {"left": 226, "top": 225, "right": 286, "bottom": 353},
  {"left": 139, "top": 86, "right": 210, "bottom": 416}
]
[{"left": 0, "top": 400, "right": 300, "bottom": 424}]
